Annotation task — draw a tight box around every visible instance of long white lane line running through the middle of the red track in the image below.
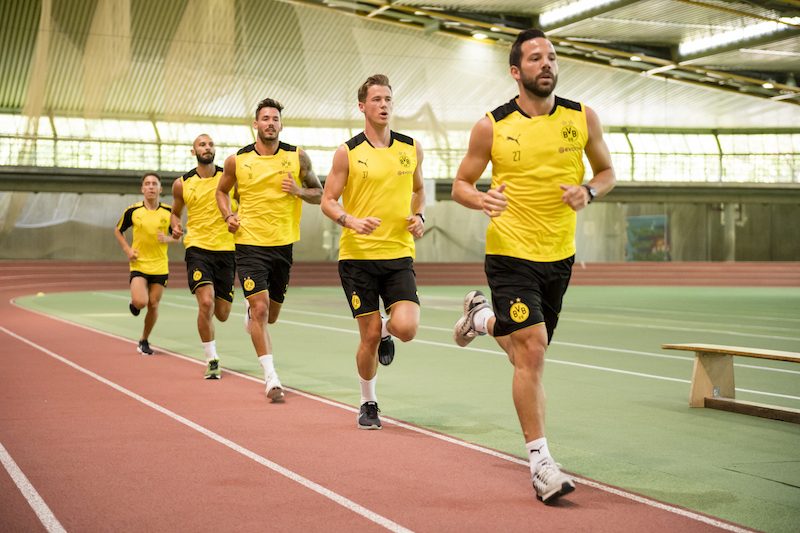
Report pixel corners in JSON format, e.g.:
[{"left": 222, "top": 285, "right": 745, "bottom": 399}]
[{"left": 0, "top": 326, "right": 411, "bottom": 532}]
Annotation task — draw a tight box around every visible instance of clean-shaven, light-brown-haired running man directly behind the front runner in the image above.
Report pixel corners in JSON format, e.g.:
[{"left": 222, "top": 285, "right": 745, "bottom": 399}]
[{"left": 322, "top": 74, "right": 425, "bottom": 429}]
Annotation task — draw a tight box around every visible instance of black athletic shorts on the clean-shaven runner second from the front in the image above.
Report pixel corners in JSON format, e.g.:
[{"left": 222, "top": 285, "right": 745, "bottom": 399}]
[{"left": 339, "top": 257, "right": 419, "bottom": 318}]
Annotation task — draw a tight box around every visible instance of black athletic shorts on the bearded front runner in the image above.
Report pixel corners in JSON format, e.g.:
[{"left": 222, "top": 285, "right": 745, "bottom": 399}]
[{"left": 484, "top": 255, "right": 575, "bottom": 343}]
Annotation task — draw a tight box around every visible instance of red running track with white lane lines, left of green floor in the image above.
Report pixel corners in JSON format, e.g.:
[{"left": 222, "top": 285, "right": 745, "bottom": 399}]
[{"left": 0, "top": 263, "right": 743, "bottom": 533}]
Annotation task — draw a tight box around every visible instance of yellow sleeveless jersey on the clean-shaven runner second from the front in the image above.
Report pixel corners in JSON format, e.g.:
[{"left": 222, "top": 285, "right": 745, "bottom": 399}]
[{"left": 339, "top": 131, "right": 417, "bottom": 260}]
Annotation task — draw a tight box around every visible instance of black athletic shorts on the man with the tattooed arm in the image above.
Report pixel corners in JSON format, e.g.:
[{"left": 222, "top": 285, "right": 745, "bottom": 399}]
[{"left": 236, "top": 244, "right": 292, "bottom": 304}]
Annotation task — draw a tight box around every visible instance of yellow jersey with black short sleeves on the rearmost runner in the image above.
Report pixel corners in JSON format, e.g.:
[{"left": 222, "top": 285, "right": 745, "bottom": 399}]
[{"left": 117, "top": 202, "right": 172, "bottom": 274}]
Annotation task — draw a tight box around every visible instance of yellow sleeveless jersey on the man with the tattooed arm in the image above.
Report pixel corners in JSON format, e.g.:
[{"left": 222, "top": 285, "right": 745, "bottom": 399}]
[{"left": 234, "top": 142, "right": 303, "bottom": 246}]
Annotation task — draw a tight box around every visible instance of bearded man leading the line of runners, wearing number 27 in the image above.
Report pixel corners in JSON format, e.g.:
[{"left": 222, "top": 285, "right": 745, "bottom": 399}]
[{"left": 452, "top": 29, "right": 615, "bottom": 503}]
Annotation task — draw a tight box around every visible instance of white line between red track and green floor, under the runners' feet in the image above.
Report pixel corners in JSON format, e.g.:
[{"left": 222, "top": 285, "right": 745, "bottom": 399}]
[{"left": 7, "top": 304, "right": 751, "bottom": 533}]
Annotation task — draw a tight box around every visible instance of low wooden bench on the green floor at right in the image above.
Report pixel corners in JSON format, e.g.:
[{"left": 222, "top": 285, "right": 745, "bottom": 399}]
[{"left": 661, "top": 344, "right": 800, "bottom": 424}]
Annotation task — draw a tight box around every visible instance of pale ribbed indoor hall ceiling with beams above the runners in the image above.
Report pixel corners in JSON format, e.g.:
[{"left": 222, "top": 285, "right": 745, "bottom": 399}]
[{"left": 0, "top": 0, "right": 800, "bottom": 132}]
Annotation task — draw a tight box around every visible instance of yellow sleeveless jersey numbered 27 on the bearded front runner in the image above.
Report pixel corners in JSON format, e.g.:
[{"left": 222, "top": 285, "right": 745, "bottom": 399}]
[{"left": 486, "top": 96, "right": 589, "bottom": 262}]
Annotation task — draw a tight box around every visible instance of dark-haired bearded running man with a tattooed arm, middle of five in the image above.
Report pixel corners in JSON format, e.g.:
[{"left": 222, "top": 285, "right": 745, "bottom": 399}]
[{"left": 216, "top": 98, "right": 322, "bottom": 402}]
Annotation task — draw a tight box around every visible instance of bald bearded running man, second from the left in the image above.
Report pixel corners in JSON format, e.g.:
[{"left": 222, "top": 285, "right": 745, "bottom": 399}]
[{"left": 171, "top": 134, "right": 236, "bottom": 379}]
